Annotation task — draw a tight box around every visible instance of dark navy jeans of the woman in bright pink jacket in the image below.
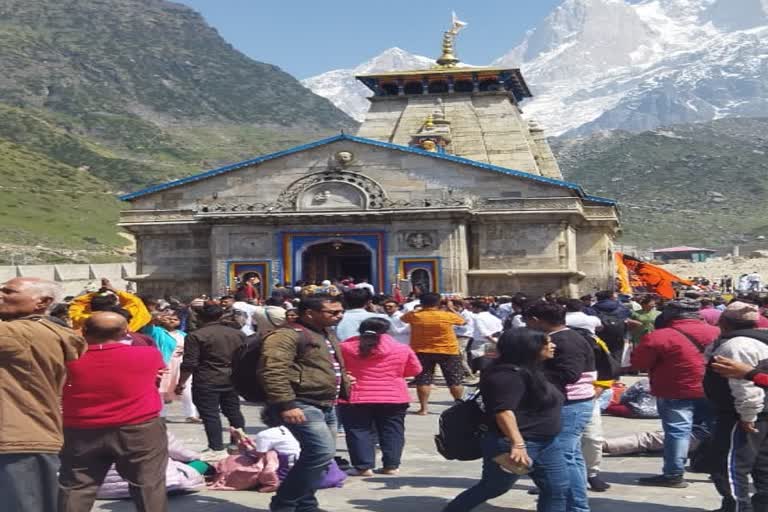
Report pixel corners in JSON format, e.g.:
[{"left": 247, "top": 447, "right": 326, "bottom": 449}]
[{"left": 339, "top": 404, "right": 408, "bottom": 471}]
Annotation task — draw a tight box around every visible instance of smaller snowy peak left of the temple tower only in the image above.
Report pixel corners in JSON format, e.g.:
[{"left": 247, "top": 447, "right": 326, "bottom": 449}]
[{"left": 301, "top": 47, "right": 435, "bottom": 121}]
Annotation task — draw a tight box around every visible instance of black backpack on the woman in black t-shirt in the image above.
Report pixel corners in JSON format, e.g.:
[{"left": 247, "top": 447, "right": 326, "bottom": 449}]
[{"left": 435, "top": 392, "right": 488, "bottom": 460}]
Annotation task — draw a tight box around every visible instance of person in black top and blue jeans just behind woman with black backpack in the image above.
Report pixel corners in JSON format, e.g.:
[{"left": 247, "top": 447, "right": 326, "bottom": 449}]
[{"left": 523, "top": 301, "right": 597, "bottom": 512}]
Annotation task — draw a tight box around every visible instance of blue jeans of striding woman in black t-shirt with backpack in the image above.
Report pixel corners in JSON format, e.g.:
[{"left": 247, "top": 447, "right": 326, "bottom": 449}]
[{"left": 443, "top": 433, "right": 568, "bottom": 512}]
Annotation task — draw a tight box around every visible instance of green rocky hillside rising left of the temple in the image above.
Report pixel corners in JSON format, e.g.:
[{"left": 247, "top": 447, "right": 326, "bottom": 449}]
[{"left": 0, "top": 0, "right": 356, "bottom": 259}]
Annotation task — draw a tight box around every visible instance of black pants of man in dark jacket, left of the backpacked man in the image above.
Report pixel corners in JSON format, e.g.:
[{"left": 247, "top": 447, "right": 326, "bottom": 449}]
[{"left": 192, "top": 386, "right": 245, "bottom": 450}]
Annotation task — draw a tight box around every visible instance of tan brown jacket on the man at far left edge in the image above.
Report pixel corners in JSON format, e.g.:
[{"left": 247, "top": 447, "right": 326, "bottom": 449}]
[{"left": 0, "top": 315, "right": 85, "bottom": 453}]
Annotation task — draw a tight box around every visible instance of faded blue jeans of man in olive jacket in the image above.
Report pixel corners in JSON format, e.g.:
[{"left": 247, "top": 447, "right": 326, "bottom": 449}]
[{"left": 269, "top": 402, "right": 336, "bottom": 512}]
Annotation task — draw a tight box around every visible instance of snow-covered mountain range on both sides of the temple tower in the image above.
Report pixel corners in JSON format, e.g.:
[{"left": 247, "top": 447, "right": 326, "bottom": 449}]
[{"left": 304, "top": 0, "right": 768, "bottom": 135}]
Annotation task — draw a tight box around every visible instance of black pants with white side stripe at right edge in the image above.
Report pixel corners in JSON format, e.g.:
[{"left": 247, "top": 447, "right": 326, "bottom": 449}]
[{"left": 710, "top": 415, "right": 768, "bottom": 512}]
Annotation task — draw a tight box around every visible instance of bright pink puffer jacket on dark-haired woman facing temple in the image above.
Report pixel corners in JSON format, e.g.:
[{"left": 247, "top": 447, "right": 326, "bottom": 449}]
[{"left": 341, "top": 334, "right": 421, "bottom": 404}]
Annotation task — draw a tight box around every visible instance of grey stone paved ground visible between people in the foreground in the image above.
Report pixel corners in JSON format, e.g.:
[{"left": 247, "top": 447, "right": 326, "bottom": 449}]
[{"left": 95, "top": 390, "right": 719, "bottom": 512}]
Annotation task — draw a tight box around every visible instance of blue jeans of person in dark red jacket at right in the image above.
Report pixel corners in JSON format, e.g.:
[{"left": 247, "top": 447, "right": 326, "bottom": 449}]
[{"left": 656, "top": 398, "right": 711, "bottom": 478}]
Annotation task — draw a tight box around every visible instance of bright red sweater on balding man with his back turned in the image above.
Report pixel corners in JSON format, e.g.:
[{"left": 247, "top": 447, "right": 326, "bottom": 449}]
[{"left": 62, "top": 343, "right": 165, "bottom": 429}]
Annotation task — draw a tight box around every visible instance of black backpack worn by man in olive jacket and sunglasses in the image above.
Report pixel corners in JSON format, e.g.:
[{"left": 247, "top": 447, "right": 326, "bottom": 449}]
[{"left": 231, "top": 324, "right": 311, "bottom": 403}]
